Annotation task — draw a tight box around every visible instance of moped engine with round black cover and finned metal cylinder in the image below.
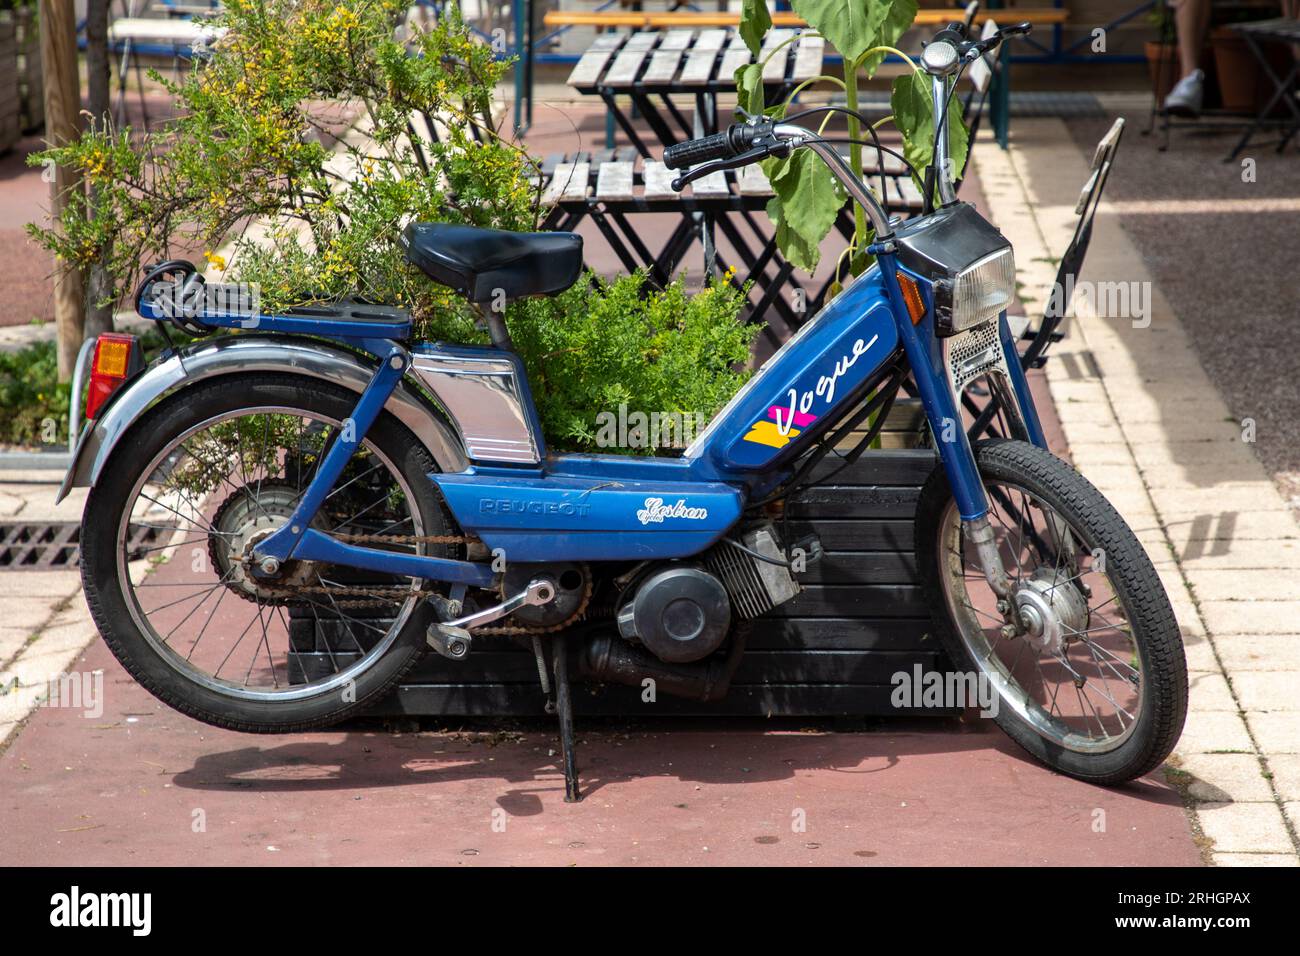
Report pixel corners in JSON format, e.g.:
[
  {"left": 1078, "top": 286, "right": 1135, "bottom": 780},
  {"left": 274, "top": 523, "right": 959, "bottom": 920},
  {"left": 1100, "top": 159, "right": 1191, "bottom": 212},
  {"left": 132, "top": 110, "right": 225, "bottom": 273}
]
[{"left": 618, "top": 523, "right": 800, "bottom": 663}]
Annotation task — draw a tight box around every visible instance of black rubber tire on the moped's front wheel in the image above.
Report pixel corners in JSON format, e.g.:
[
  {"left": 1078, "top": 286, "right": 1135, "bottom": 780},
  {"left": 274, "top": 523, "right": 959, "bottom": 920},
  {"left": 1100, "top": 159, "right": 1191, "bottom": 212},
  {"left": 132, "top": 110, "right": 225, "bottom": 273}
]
[{"left": 917, "top": 440, "right": 1187, "bottom": 784}]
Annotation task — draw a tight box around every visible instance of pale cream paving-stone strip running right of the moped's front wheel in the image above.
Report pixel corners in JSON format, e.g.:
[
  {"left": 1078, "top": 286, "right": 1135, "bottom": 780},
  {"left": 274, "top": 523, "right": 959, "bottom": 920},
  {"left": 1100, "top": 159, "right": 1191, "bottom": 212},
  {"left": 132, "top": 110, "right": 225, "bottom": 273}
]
[{"left": 975, "top": 120, "right": 1300, "bottom": 866}]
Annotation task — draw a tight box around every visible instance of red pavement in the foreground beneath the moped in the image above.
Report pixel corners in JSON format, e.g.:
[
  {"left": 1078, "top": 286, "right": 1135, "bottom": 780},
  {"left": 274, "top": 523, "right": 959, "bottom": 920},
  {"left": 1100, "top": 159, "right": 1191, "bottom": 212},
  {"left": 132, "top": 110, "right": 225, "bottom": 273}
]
[{"left": 0, "top": 634, "right": 1200, "bottom": 866}]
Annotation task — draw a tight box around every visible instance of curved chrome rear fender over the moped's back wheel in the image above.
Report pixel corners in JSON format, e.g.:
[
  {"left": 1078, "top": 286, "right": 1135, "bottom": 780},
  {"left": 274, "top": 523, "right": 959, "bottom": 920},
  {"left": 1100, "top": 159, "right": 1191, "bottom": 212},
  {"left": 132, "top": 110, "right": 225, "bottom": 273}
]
[{"left": 56, "top": 336, "right": 469, "bottom": 501}]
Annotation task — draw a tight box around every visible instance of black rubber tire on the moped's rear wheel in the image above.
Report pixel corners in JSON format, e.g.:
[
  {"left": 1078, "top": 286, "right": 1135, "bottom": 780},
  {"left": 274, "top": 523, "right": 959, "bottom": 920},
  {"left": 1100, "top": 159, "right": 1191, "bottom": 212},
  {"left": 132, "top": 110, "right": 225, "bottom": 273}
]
[{"left": 81, "top": 375, "right": 454, "bottom": 734}]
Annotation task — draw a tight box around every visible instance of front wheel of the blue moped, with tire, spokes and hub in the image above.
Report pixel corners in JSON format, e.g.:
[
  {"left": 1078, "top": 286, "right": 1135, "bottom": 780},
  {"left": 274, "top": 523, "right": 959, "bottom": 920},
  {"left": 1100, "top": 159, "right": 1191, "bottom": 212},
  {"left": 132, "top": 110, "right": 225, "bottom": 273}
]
[{"left": 917, "top": 440, "right": 1187, "bottom": 784}]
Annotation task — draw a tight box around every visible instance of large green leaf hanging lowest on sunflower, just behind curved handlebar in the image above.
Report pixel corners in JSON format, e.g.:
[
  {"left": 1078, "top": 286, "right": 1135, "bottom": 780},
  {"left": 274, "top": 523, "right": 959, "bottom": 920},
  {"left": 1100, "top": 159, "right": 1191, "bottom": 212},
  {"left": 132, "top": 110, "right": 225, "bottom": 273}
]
[{"left": 763, "top": 150, "right": 845, "bottom": 272}]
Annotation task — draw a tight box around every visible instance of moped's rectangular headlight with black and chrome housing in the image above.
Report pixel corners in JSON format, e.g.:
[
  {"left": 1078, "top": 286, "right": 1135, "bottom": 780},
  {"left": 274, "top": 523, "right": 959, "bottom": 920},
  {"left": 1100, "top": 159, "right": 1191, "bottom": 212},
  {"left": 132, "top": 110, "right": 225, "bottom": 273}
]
[{"left": 894, "top": 203, "right": 1015, "bottom": 336}]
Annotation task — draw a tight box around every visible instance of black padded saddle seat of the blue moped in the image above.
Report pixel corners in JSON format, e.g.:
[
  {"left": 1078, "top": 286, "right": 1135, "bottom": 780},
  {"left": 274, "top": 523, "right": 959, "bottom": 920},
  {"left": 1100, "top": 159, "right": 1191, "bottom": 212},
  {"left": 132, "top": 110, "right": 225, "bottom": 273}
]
[{"left": 402, "top": 222, "right": 582, "bottom": 302}]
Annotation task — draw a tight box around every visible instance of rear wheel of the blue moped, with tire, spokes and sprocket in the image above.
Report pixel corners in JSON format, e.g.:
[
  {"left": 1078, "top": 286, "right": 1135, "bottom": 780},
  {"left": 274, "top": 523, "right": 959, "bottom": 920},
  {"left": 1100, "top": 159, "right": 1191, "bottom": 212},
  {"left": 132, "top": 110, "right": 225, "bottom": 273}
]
[{"left": 82, "top": 375, "right": 451, "bottom": 734}]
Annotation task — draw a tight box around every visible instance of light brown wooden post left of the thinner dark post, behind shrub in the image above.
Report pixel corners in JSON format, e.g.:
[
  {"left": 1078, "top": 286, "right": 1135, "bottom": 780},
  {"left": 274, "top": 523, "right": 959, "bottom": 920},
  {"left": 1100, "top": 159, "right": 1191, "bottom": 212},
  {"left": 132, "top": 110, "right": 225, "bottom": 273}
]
[{"left": 40, "top": 0, "right": 86, "bottom": 381}]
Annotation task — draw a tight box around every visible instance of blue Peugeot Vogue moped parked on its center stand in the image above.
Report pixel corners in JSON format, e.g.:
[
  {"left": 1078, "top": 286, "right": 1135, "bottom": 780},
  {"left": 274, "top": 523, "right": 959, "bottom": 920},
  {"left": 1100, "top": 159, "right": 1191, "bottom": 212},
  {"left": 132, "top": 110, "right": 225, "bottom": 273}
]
[{"left": 64, "top": 26, "right": 1187, "bottom": 799}]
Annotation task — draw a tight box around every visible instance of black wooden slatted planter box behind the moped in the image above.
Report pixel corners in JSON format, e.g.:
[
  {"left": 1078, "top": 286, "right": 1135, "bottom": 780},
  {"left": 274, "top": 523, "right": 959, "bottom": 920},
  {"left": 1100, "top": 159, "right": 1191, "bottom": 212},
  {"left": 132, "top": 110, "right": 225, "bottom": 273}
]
[{"left": 290, "top": 402, "right": 950, "bottom": 717}]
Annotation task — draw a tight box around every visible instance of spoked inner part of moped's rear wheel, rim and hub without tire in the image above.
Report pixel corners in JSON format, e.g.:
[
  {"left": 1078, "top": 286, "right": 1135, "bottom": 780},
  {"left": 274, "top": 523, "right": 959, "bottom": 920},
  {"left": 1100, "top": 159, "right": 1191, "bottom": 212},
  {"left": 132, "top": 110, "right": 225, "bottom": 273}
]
[{"left": 118, "top": 407, "right": 428, "bottom": 700}]
